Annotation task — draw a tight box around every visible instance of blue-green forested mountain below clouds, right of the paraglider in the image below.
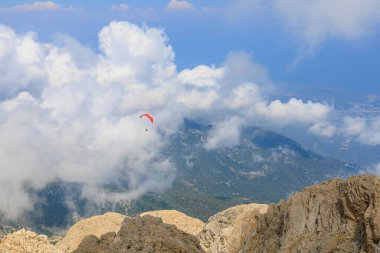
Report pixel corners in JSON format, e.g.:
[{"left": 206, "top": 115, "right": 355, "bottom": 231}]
[{"left": 130, "top": 120, "right": 361, "bottom": 220}]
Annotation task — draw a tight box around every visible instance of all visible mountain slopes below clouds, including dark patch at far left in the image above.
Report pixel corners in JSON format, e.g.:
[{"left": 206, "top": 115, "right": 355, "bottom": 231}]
[{"left": 0, "top": 120, "right": 361, "bottom": 233}]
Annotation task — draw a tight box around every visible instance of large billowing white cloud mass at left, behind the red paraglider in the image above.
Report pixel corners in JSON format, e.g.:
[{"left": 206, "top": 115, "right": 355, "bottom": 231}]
[{"left": 0, "top": 22, "right": 179, "bottom": 218}]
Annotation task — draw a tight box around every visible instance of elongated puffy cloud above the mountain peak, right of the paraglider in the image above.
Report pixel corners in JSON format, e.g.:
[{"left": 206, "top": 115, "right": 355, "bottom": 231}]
[{"left": 178, "top": 49, "right": 334, "bottom": 132}]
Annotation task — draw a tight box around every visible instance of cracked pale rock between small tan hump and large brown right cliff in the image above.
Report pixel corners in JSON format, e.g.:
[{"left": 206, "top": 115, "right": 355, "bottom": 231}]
[{"left": 199, "top": 204, "right": 268, "bottom": 253}]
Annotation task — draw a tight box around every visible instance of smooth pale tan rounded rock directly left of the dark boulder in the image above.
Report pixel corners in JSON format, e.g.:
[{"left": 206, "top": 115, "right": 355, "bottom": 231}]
[{"left": 56, "top": 212, "right": 127, "bottom": 253}]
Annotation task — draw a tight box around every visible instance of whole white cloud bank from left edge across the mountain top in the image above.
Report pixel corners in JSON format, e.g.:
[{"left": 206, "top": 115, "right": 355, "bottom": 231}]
[{"left": 0, "top": 22, "right": 370, "bottom": 218}]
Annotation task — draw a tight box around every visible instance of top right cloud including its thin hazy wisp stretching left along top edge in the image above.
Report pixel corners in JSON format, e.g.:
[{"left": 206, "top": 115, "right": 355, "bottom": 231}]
[{"left": 219, "top": 0, "right": 380, "bottom": 55}]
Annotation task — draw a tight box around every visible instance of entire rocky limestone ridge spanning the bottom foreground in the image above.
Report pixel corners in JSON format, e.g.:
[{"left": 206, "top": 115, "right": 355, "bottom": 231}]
[{"left": 0, "top": 175, "right": 380, "bottom": 253}]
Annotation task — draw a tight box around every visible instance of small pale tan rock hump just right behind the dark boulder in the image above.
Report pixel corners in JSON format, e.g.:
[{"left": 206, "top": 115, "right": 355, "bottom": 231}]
[{"left": 140, "top": 210, "right": 205, "bottom": 236}]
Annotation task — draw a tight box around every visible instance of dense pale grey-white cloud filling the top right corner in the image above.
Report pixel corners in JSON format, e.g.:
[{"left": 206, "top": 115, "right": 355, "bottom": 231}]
[{"left": 273, "top": 0, "right": 380, "bottom": 54}]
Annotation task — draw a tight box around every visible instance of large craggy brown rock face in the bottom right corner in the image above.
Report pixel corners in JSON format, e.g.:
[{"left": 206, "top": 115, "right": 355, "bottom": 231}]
[{"left": 241, "top": 175, "right": 380, "bottom": 253}]
